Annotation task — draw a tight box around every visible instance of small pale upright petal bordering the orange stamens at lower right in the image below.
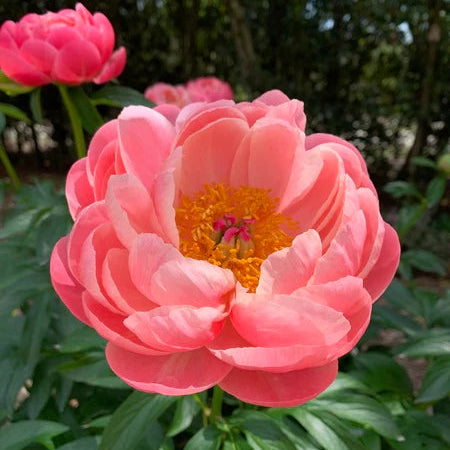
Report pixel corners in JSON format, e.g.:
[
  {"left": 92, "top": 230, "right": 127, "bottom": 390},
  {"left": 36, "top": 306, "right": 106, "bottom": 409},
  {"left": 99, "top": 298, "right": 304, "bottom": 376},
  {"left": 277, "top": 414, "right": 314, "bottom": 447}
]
[{"left": 256, "top": 230, "right": 322, "bottom": 294}]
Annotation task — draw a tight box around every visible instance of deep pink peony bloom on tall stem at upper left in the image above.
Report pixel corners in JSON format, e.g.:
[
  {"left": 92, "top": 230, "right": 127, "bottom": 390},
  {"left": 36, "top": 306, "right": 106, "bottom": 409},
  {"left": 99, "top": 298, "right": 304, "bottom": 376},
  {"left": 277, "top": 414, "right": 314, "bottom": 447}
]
[{"left": 0, "top": 3, "right": 126, "bottom": 86}]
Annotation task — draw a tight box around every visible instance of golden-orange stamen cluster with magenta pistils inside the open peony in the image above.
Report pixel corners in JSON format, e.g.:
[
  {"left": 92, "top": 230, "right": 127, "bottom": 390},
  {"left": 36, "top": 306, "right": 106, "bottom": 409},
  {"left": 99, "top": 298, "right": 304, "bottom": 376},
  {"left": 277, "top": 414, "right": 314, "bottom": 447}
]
[{"left": 176, "top": 183, "right": 298, "bottom": 292}]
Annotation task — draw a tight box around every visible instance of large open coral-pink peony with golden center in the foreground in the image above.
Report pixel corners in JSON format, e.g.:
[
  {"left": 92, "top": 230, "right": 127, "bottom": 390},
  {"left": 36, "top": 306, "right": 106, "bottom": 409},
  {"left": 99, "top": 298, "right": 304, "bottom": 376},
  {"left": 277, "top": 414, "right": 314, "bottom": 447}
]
[{"left": 51, "top": 91, "right": 400, "bottom": 406}]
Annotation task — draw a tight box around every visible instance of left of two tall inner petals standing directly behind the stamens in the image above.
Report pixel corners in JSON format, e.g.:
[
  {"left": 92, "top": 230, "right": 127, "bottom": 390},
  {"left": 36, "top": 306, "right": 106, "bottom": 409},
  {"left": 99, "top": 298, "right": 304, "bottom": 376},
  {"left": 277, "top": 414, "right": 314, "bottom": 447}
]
[{"left": 180, "top": 118, "right": 248, "bottom": 196}]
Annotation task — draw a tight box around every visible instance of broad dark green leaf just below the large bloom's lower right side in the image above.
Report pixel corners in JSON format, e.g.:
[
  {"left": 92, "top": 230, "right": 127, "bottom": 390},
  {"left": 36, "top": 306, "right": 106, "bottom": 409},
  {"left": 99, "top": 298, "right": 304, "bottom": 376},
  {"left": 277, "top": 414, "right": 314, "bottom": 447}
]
[{"left": 351, "top": 352, "right": 412, "bottom": 395}]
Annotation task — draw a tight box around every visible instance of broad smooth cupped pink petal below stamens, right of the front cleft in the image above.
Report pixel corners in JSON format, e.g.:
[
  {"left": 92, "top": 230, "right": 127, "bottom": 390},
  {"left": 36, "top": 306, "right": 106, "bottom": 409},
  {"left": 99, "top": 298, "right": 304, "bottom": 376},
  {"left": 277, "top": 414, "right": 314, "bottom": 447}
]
[{"left": 231, "top": 294, "right": 350, "bottom": 347}]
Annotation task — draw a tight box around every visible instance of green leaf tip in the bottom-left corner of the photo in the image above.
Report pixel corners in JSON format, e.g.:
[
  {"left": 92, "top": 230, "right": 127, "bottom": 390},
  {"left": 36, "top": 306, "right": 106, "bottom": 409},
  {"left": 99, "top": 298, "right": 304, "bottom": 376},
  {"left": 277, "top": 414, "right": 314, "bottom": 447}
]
[{"left": 0, "top": 420, "right": 68, "bottom": 450}]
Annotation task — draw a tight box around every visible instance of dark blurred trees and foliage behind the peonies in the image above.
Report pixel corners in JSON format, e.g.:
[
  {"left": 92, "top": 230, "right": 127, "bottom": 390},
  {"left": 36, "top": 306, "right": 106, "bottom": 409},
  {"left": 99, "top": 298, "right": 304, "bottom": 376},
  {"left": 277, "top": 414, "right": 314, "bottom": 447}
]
[{"left": 0, "top": 0, "right": 450, "bottom": 182}]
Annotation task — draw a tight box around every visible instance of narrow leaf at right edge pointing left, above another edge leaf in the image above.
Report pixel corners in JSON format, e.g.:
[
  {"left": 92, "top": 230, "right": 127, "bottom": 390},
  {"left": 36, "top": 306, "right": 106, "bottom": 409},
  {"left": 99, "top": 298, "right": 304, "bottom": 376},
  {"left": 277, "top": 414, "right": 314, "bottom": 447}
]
[{"left": 395, "top": 328, "right": 450, "bottom": 358}]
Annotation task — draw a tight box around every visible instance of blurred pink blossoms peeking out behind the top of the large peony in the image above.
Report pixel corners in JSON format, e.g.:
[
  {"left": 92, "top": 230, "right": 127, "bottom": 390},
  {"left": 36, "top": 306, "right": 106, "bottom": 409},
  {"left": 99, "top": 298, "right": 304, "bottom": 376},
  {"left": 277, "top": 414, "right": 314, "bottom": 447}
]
[{"left": 144, "top": 77, "right": 233, "bottom": 106}]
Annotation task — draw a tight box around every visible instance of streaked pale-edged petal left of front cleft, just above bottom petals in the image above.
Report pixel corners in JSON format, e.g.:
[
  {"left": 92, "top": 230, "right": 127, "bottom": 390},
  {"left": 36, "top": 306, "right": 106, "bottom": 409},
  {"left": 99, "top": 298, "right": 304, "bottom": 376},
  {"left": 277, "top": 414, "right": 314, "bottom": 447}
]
[{"left": 124, "top": 305, "right": 225, "bottom": 352}]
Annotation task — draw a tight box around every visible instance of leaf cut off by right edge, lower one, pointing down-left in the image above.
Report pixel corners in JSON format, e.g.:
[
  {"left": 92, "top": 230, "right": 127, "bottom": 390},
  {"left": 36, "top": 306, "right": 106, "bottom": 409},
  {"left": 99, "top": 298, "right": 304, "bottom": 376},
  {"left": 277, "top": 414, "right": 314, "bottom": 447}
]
[{"left": 416, "top": 356, "right": 450, "bottom": 403}]
